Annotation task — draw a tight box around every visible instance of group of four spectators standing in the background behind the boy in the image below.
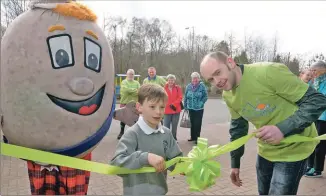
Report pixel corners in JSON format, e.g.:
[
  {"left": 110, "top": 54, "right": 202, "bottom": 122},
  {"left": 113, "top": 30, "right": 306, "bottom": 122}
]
[{"left": 117, "top": 67, "right": 208, "bottom": 143}]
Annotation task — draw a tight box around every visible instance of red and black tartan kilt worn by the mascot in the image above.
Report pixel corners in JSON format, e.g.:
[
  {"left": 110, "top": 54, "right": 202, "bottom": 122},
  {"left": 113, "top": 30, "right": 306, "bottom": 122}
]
[{"left": 27, "top": 153, "right": 91, "bottom": 195}]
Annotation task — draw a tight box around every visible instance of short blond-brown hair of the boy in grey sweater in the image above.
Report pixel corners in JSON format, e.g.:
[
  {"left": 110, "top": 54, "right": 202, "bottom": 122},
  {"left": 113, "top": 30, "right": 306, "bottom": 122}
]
[{"left": 138, "top": 84, "right": 168, "bottom": 104}]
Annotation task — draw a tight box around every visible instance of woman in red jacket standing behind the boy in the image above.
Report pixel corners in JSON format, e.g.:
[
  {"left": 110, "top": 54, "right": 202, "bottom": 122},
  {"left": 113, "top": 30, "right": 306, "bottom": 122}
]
[{"left": 163, "top": 74, "right": 182, "bottom": 140}]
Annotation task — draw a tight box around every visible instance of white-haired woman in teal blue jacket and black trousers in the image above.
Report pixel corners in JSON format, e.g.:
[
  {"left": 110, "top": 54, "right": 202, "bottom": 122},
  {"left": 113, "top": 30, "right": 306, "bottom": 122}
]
[{"left": 184, "top": 72, "right": 208, "bottom": 144}]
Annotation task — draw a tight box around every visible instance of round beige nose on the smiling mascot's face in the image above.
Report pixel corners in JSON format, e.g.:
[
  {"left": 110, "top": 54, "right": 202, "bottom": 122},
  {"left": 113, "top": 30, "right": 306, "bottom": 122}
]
[{"left": 69, "top": 77, "right": 94, "bottom": 95}]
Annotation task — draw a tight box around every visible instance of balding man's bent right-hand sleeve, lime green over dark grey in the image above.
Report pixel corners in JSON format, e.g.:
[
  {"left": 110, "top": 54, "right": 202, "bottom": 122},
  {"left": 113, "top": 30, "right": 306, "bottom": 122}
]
[{"left": 266, "top": 64, "right": 326, "bottom": 137}]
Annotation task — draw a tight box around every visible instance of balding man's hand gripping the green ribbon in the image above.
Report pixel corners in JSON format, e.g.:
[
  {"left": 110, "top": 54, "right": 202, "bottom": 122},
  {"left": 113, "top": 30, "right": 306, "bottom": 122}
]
[{"left": 256, "top": 125, "right": 284, "bottom": 144}]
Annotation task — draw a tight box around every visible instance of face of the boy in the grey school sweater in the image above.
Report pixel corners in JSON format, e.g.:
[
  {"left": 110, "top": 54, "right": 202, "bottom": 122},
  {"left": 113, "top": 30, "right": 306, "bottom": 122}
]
[{"left": 137, "top": 99, "right": 166, "bottom": 129}]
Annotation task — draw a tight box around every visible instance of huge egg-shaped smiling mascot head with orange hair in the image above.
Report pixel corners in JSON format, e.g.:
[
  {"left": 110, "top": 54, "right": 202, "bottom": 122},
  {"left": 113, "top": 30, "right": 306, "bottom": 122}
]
[{"left": 1, "top": 0, "right": 114, "bottom": 157}]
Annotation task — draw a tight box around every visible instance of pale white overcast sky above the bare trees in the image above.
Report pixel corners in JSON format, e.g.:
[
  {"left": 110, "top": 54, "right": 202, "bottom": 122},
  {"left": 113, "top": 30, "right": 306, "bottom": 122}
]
[{"left": 83, "top": 1, "right": 326, "bottom": 55}]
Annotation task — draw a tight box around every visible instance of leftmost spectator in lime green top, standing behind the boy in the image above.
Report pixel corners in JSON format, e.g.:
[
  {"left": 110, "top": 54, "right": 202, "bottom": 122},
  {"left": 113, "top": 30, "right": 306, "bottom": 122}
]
[{"left": 117, "top": 69, "right": 140, "bottom": 140}]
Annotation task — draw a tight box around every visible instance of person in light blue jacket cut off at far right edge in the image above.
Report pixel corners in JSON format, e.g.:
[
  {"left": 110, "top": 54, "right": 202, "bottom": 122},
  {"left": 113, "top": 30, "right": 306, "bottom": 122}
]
[{"left": 305, "top": 61, "right": 326, "bottom": 178}]
